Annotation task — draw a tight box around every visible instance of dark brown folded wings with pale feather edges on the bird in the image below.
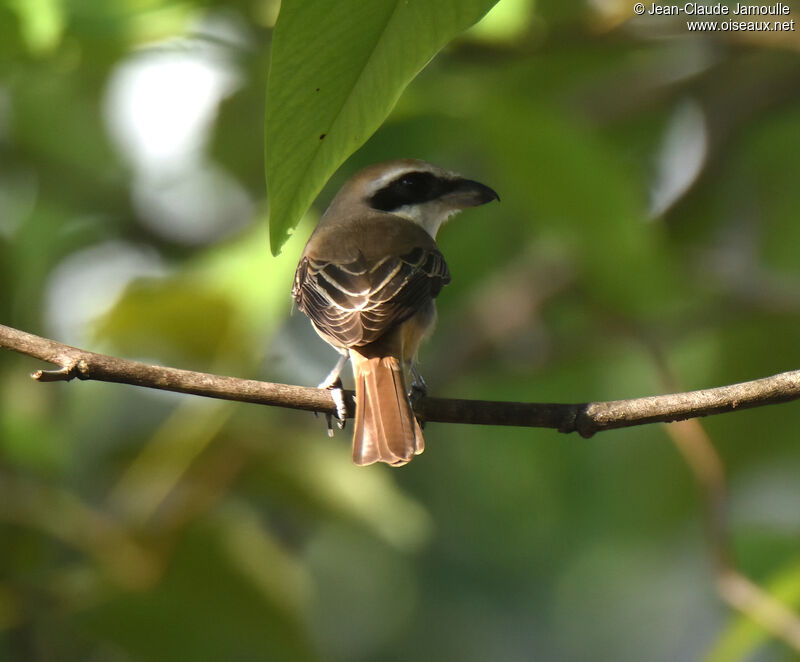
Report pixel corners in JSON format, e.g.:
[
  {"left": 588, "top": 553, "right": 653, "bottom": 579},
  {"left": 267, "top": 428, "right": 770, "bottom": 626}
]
[{"left": 292, "top": 246, "right": 450, "bottom": 347}]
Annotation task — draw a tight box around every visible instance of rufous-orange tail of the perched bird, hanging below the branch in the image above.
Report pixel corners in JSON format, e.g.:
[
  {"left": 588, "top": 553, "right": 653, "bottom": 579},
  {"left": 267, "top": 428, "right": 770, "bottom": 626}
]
[{"left": 351, "top": 352, "right": 425, "bottom": 467}]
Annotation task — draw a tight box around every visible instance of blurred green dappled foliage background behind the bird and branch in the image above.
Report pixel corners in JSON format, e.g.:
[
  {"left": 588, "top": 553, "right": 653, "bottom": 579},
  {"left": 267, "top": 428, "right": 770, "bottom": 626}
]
[{"left": 0, "top": 0, "right": 800, "bottom": 662}]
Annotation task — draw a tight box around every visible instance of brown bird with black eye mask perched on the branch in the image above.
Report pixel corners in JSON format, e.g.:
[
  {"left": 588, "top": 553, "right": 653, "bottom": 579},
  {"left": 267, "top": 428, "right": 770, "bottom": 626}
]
[{"left": 292, "top": 159, "right": 500, "bottom": 467}]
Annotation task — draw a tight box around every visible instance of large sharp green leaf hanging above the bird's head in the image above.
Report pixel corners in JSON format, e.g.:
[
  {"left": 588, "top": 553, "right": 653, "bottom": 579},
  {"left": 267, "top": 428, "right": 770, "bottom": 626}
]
[{"left": 266, "top": 0, "right": 496, "bottom": 254}]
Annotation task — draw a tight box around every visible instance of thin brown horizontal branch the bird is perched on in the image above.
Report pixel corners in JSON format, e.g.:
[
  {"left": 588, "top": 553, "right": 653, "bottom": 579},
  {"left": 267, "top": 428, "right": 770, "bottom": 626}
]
[{"left": 0, "top": 324, "right": 800, "bottom": 437}]
